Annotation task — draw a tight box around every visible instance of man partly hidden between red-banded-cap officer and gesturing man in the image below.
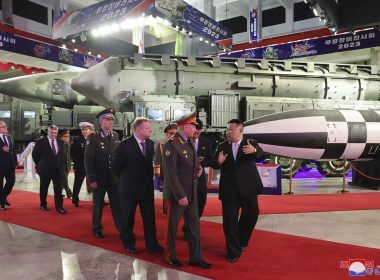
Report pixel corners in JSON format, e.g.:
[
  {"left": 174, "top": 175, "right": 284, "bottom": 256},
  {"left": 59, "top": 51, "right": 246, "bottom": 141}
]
[{"left": 193, "top": 120, "right": 212, "bottom": 218}]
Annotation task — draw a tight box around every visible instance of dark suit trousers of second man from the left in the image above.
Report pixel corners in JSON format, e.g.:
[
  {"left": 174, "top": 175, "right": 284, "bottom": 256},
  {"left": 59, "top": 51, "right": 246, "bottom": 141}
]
[{"left": 39, "top": 168, "right": 63, "bottom": 209}]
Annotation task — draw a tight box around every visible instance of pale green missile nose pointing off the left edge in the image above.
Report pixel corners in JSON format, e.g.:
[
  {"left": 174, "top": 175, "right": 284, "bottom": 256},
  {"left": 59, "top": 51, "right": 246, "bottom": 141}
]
[{"left": 0, "top": 71, "right": 95, "bottom": 108}]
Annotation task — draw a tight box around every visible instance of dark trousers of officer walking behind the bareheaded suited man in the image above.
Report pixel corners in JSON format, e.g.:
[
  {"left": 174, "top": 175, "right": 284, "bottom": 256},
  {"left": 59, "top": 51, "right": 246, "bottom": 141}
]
[{"left": 92, "top": 185, "right": 121, "bottom": 232}]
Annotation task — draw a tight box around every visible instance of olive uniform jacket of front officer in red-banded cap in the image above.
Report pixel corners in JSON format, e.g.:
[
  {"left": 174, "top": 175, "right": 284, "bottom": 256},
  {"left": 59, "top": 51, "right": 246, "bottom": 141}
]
[{"left": 162, "top": 133, "right": 198, "bottom": 203}]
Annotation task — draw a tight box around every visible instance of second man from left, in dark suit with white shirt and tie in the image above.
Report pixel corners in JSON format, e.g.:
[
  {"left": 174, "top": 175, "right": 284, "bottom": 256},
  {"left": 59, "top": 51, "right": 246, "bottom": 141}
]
[{"left": 32, "top": 125, "right": 66, "bottom": 214}]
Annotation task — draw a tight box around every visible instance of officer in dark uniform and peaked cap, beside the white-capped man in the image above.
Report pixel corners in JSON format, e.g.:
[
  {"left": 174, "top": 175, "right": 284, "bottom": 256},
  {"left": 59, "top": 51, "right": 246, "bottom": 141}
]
[{"left": 84, "top": 109, "right": 121, "bottom": 238}]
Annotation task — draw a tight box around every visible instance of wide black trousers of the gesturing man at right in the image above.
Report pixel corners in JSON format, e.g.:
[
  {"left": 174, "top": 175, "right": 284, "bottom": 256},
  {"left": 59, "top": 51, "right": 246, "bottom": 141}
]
[{"left": 222, "top": 196, "right": 259, "bottom": 258}]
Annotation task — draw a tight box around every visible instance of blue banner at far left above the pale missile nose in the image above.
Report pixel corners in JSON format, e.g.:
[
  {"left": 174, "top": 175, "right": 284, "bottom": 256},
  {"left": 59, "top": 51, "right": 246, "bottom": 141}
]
[{"left": 0, "top": 32, "right": 103, "bottom": 68}]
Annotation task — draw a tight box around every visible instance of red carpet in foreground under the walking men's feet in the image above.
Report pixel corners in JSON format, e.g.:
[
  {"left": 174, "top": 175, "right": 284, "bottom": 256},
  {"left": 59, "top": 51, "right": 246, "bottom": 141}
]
[{"left": 0, "top": 191, "right": 380, "bottom": 280}]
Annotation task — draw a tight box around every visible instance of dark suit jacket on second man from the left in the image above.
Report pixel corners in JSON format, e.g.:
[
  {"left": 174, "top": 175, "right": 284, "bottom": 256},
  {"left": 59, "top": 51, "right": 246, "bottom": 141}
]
[{"left": 32, "top": 137, "right": 65, "bottom": 176}]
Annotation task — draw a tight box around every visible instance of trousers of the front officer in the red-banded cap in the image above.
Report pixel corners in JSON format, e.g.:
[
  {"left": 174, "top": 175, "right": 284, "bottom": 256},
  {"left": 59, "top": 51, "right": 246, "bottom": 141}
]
[{"left": 164, "top": 200, "right": 203, "bottom": 262}]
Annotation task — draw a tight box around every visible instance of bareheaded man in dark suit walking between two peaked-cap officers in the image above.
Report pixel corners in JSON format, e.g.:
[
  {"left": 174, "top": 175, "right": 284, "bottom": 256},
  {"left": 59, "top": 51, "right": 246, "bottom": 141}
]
[{"left": 112, "top": 118, "right": 164, "bottom": 253}]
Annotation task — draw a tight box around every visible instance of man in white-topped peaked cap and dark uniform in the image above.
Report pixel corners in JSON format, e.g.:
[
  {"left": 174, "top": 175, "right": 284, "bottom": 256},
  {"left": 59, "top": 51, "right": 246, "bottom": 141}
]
[{"left": 71, "top": 122, "right": 94, "bottom": 207}]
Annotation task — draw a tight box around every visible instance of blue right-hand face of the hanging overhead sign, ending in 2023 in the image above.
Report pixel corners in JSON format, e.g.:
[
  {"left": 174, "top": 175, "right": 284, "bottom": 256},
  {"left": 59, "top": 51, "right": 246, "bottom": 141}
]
[{"left": 155, "top": 0, "right": 232, "bottom": 42}]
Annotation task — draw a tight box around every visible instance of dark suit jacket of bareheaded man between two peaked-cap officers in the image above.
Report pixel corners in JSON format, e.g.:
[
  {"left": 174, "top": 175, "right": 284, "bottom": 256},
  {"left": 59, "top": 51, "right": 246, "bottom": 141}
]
[{"left": 112, "top": 135, "right": 154, "bottom": 200}]
